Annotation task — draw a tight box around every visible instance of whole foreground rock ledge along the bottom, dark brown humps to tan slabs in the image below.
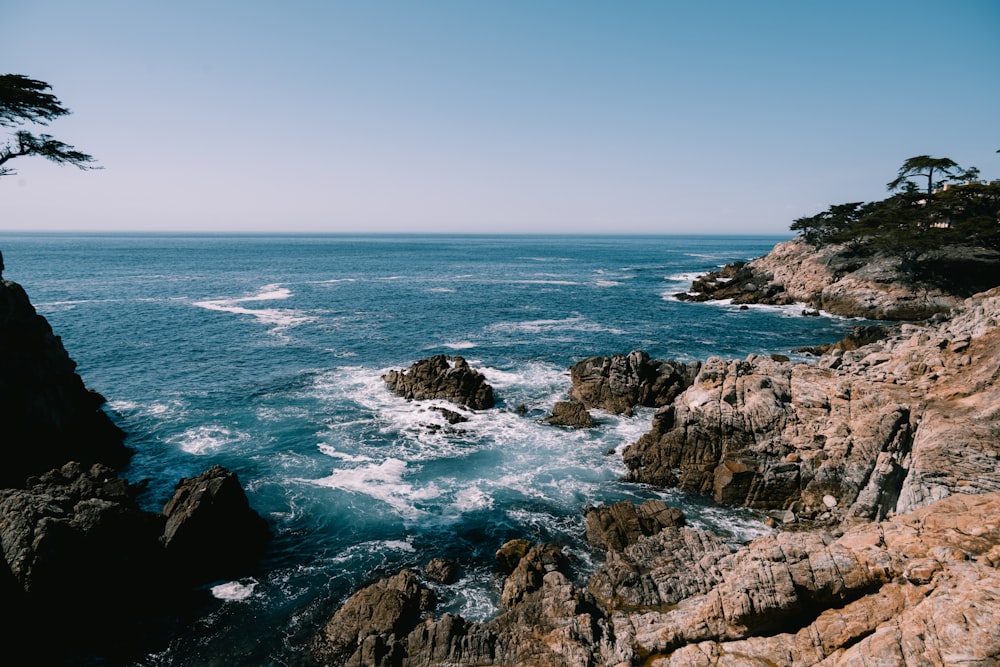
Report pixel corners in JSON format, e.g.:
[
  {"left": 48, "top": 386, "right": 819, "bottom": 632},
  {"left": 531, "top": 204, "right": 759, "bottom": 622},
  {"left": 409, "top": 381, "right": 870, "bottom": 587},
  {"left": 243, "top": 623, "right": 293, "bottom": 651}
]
[{"left": 314, "top": 493, "right": 1000, "bottom": 667}]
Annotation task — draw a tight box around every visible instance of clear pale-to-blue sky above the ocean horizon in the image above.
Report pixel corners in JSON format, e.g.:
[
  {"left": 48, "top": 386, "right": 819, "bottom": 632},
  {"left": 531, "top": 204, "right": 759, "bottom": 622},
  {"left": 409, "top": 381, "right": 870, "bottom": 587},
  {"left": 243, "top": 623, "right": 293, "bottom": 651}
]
[{"left": 0, "top": 0, "right": 1000, "bottom": 234}]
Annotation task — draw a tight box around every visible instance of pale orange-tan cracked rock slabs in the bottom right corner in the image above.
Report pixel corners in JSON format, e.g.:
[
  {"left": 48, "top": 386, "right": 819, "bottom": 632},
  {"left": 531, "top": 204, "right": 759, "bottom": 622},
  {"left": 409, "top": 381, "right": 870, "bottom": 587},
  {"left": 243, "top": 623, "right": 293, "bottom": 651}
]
[{"left": 628, "top": 493, "right": 1000, "bottom": 666}]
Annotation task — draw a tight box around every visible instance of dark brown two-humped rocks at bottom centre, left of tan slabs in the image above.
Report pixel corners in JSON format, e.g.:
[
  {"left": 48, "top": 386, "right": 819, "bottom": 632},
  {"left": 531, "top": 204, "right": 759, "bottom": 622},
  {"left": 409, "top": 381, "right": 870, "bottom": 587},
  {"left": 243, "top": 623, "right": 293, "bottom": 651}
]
[{"left": 313, "top": 545, "right": 620, "bottom": 667}]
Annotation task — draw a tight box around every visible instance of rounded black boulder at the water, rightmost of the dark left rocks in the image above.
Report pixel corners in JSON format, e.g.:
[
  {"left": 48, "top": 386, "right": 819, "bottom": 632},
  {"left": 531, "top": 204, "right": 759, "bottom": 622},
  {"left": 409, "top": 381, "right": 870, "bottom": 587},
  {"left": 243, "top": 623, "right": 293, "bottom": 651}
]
[{"left": 162, "top": 465, "right": 270, "bottom": 581}]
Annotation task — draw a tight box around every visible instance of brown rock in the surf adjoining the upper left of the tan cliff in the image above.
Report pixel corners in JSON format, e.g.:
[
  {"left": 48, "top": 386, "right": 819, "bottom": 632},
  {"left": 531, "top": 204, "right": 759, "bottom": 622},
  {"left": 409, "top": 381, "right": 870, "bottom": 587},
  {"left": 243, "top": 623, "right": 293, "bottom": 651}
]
[{"left": 570, "top": 350, "right": 700, "bottom": 414}]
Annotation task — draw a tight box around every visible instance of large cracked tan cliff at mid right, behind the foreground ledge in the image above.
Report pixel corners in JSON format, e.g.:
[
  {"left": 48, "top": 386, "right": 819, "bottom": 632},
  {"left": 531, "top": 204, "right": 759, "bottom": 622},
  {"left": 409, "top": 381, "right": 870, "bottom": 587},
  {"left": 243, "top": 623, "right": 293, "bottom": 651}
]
[{"left": 624, "top": 289, "right": 1000, "bottom": 521}]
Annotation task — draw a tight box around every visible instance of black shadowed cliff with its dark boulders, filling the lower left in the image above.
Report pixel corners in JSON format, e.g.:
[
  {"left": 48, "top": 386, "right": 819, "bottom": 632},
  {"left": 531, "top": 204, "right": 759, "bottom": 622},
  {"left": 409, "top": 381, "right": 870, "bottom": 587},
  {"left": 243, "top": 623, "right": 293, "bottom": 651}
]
[{"left": 0, "top": 281, "right": 268, "bottom": 664}]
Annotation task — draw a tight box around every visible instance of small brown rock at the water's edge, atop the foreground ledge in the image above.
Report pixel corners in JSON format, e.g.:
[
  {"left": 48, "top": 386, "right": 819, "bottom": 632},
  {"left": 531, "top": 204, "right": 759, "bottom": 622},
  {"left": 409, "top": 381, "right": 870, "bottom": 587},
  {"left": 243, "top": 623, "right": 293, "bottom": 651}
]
[{"left": 584, "top": 500, "right": 685, "bottom": 551}]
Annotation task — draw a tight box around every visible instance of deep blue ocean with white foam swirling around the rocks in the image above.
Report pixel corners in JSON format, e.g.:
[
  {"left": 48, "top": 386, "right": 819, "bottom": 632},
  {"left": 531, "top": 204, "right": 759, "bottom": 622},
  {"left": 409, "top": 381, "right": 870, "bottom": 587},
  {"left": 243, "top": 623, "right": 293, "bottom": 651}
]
[{"left": 0, "top": 233, "right": 856, "bottom": 665}]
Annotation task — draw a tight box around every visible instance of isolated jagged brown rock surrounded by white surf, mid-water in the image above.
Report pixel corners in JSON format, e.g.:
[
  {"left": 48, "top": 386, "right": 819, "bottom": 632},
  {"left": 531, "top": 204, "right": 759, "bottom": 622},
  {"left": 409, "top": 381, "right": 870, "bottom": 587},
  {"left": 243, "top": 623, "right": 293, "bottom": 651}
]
[{"left": 382, "top": 354, "right": 494, "bottom": 410}]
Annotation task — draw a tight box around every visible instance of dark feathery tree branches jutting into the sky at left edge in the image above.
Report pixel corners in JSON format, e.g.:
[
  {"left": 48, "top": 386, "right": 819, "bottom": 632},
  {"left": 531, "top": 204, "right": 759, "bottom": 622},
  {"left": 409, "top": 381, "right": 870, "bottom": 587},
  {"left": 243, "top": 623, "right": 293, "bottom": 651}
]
[{"left": 0, "top": 74, "right": 101, "bottom": 176}]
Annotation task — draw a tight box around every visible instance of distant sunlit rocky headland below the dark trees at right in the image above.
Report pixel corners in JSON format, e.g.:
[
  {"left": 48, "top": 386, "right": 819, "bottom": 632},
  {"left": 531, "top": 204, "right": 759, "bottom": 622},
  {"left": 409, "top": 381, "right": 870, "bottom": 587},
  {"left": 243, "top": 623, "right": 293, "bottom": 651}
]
[{"left": 677, "top": 239, "right": 1000, "bottom": 320}]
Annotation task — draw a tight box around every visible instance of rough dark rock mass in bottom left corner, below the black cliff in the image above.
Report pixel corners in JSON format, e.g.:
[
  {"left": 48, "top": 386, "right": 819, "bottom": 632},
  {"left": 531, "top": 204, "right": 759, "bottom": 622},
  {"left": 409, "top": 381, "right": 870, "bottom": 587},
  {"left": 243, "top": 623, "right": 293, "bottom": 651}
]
[{"left": 0, "top": 463, "right": 176, "bottom": 664}]
